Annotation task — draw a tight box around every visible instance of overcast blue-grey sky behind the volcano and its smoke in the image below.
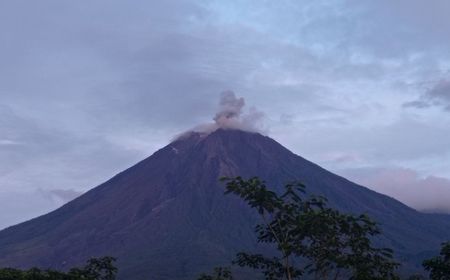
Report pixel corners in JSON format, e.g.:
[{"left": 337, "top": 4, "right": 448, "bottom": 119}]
[{"left": 0, "top": 0, "right": 450, "bottom": 228}]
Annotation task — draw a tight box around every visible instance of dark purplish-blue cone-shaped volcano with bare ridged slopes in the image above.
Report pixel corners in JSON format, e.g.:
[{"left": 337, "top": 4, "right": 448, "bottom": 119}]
[{"left": 0, "top": 129, "right": 450, "bottom": 280}]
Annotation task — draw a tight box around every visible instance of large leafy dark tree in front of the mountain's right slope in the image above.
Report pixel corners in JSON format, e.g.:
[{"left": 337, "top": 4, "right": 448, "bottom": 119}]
[{"left": 199, "top": 177, "right": 399, "bottom": 280}]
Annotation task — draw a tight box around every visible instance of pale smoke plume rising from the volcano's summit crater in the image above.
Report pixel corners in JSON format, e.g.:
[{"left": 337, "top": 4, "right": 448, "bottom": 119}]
[{"left": 175, "top": 90, "right": 267, "bottom": 139}]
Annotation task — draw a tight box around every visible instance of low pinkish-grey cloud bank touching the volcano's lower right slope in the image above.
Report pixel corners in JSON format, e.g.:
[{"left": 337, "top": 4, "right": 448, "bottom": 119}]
[{"left": 340, "top": 168, "right": 450, "bottom": 213}]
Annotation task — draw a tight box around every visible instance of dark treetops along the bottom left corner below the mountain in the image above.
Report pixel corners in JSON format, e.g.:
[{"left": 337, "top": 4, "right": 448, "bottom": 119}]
[{"left": 0, "top": 257, "right": 117, "bottom": 280}]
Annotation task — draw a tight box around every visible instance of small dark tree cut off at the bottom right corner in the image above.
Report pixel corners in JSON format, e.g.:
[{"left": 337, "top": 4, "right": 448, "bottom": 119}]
[{"left": 423, "top": 242, "right": 450, "bottom": 280}]
